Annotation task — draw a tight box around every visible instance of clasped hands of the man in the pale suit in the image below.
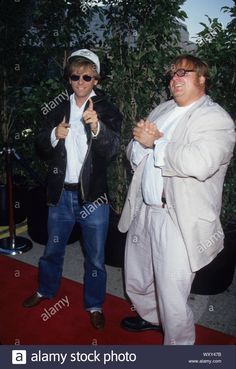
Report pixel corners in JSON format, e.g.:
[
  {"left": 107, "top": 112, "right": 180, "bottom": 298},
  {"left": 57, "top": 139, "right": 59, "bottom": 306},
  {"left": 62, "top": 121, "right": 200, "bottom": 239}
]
[{"left": 133, "top": 119, "right": 163, "bottom": 148}]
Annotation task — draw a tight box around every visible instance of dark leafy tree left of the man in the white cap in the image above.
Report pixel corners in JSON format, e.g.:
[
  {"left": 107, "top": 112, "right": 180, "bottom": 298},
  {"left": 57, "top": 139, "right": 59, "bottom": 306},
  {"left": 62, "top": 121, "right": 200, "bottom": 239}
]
[{"left": 0, "top": 0, "right": 97, "bottom": 181}]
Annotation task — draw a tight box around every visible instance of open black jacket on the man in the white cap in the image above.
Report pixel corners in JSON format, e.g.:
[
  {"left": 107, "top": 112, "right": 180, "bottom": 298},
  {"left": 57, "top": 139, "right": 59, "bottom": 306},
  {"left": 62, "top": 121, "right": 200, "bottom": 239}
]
[{"left": 36, "top": 89, "right": 123, "bottom": 205}]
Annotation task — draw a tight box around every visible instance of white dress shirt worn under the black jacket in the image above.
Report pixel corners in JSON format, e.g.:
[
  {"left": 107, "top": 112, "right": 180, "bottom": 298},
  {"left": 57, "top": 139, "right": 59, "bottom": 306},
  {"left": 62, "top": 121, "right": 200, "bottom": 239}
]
[{"left": 51, "top": 91, "right": 100, "bottom": 183}]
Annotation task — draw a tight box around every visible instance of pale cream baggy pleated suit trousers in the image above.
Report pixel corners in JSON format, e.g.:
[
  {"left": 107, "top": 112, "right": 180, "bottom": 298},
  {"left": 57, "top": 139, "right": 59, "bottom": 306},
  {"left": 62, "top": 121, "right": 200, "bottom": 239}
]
[{"left": 125, "top": 203, "right": 195, "bottom": 345}]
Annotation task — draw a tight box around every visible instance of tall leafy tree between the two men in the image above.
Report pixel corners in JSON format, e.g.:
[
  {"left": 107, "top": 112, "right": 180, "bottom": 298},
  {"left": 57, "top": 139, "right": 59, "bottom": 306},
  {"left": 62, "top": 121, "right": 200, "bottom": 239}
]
[{"left": 96, "top": 0, "right": 186, "bottom": 211}]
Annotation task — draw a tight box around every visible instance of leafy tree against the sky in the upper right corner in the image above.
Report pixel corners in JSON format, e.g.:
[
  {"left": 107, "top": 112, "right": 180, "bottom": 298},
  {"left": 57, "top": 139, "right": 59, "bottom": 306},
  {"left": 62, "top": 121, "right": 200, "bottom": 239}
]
[{"left": 197, "top": 6, "right": 236, "bottom": 120}]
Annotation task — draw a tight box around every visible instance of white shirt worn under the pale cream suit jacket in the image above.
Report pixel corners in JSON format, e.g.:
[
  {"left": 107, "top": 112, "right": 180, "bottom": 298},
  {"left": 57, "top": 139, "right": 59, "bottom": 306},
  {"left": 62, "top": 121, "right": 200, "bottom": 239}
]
[{"left": 131, "top": 102, "right": 195, "bottom": 205}]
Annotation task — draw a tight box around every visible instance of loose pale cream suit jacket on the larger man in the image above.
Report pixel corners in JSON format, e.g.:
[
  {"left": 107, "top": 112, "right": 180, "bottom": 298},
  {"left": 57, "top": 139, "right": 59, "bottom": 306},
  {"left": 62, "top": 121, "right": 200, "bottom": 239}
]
[{"left": 118, "top": 95, "right": 235, "bottom": 272}]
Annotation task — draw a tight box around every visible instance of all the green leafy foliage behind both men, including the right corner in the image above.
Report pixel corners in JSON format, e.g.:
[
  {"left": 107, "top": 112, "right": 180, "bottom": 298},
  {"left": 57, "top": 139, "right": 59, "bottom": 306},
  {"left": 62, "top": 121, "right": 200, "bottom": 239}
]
[{"left": 0, "top": 0, "right": 236, "bottom": 224}]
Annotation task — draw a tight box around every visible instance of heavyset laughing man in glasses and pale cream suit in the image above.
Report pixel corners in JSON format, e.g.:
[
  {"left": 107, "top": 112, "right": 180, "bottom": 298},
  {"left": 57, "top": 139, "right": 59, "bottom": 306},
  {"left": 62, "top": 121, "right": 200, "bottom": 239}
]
[{"left": 119, "top": 55, "right": 235, "bottom": 345}]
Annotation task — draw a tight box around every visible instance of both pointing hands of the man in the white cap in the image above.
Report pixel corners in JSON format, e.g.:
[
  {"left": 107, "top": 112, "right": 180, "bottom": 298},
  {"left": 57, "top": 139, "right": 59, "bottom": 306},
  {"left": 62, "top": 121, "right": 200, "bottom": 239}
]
[{"left": 55, "top": 99, "right": 98, "bottom": 140}]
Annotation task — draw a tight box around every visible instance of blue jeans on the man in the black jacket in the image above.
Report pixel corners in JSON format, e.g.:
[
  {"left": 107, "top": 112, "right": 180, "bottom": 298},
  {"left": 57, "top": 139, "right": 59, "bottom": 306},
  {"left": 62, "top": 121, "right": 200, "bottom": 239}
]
[{"left": 38, "top": 190, "right": 109, "bottom": 310}]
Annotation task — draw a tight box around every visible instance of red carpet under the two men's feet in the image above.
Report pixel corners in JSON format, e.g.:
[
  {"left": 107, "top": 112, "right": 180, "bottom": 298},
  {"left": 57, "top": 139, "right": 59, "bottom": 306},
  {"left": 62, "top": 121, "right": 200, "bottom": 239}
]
[{"left": 0, "top": 255, "right": 236, "bottom": 345}]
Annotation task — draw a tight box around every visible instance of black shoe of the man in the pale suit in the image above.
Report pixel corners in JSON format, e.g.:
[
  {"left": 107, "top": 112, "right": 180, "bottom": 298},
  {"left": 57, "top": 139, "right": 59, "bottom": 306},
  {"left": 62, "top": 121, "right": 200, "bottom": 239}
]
[{"left": 120, "top": 316, "right": 162, "bottom": 332}]
